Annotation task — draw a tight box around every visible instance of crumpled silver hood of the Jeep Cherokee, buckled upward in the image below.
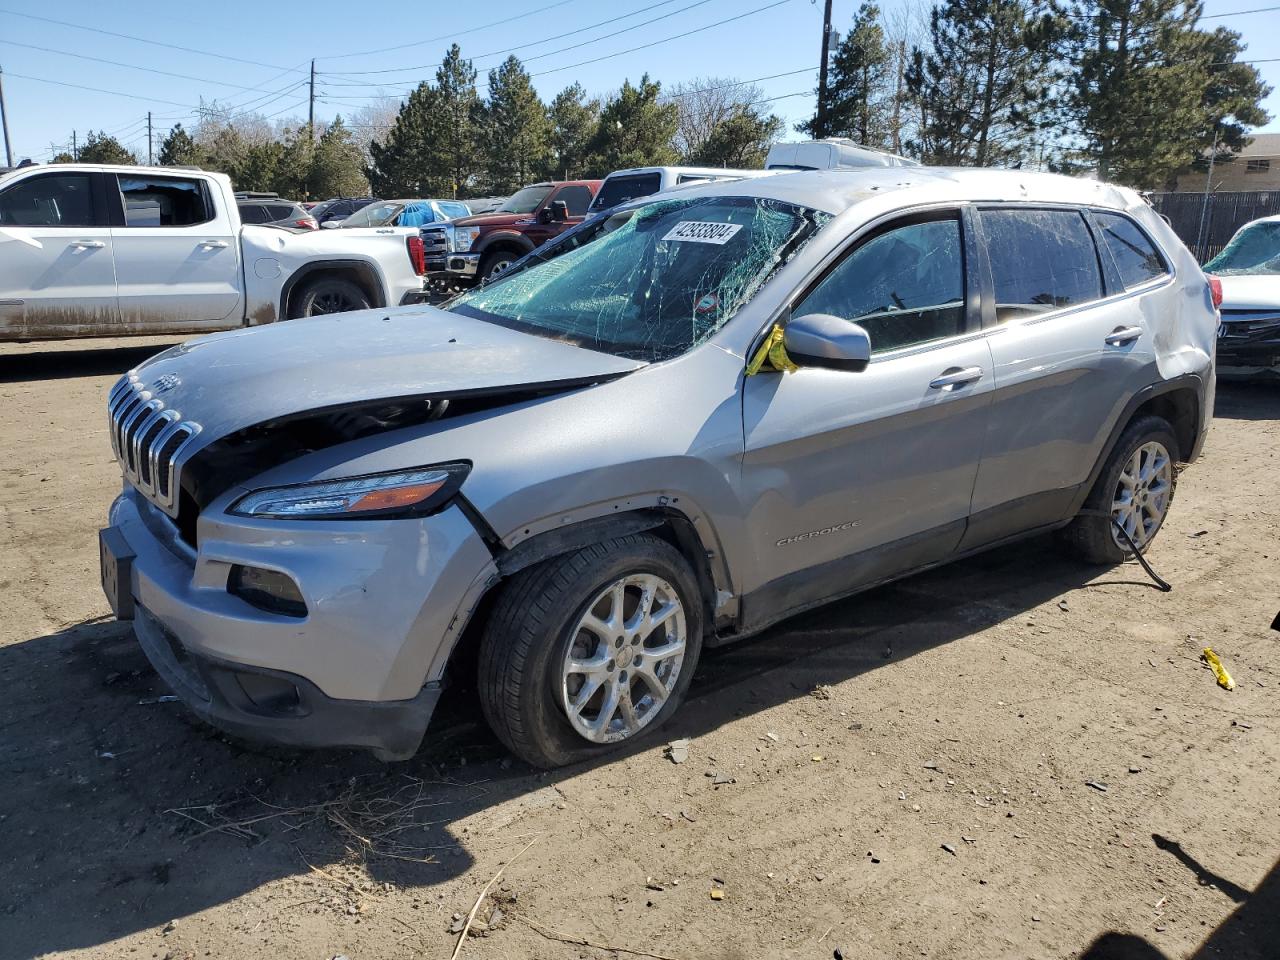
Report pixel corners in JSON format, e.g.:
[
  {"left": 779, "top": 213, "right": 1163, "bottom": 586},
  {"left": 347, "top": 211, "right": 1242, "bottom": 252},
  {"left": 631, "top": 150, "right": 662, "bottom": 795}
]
[{"left": 131, "top": 306, "right": 645, "bottom": 452}]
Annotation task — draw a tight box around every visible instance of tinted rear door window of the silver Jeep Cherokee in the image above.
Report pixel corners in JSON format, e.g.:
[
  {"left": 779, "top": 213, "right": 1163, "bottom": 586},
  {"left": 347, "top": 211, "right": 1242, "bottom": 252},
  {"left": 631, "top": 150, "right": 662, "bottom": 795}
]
[{"left": 982, "top": 207, "right": 1102, "bottom": 323}]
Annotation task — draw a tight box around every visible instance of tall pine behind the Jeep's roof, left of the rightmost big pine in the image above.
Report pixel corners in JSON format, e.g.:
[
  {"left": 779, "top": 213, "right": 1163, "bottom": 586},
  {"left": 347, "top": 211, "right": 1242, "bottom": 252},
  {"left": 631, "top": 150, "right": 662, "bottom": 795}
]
[{"left": 906, "top": 0, "right": 1056, "bottom": 166}]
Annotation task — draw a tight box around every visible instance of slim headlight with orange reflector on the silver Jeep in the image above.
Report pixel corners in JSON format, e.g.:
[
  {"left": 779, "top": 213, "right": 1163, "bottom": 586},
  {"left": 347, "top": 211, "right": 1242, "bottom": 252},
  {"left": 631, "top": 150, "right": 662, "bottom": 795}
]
[{"left": 230, "top": 463, "right": 471, "bottom": 520}]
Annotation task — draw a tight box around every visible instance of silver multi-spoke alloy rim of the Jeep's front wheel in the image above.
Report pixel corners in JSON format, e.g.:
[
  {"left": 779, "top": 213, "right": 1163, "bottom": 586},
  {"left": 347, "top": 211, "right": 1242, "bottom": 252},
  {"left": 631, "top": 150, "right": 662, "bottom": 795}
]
[{"left": 561, "top": 573, "right": 687, "bottom": 744}]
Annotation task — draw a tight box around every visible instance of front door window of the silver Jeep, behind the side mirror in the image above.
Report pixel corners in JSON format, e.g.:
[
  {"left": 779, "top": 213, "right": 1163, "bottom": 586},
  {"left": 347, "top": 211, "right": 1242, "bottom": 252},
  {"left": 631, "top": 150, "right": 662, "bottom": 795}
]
[{"left": 791, "top": 215, "right": 965, "bottom": 353}]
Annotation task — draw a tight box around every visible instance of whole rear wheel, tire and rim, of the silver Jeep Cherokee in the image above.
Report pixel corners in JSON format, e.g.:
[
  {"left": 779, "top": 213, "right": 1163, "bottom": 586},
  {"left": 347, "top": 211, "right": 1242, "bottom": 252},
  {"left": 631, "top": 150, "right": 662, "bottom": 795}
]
[{"left": 1062, "top": 416, "right": 1179, "bottom": 564}]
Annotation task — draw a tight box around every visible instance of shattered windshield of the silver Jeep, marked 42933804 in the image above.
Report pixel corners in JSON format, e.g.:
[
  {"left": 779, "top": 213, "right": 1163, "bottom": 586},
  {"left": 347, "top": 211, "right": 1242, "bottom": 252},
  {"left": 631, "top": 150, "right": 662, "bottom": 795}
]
[{"left": 445, "top": 197, "right": 828, "bottom": 361}]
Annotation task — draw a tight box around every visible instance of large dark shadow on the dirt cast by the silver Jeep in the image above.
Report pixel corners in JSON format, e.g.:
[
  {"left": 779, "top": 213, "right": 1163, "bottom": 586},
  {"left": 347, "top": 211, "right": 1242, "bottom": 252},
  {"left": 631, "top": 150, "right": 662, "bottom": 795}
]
[{"left": 0, "top": 539, "right": 1167, "bottom": 956}]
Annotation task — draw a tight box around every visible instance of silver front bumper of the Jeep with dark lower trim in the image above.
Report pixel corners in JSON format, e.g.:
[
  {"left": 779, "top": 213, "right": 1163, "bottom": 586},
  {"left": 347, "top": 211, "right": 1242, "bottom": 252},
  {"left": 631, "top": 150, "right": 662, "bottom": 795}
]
[{"left": 104, "top": 488, "right": 492, "bottom": 759}]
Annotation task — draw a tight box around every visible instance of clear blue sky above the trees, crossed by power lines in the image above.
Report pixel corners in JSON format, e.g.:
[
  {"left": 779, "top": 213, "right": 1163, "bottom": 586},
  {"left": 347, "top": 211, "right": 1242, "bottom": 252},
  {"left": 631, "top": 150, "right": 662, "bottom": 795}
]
[{"left": 0, "top": 0, "right": 1280, "bottom": 160}]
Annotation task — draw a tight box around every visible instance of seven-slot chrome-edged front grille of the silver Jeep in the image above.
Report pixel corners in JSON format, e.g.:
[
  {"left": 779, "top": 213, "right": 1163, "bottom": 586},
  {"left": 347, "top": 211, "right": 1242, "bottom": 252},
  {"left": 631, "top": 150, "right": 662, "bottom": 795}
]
[{"left": 106, "top": 374, "right": 200, "bottom": 517}]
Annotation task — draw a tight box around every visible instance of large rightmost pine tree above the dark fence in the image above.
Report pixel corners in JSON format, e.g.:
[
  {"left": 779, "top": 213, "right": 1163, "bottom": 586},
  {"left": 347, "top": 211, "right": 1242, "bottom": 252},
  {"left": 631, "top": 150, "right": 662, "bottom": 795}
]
[{"left": 1064, "top": 0, "right": 1270, "bottom": 188}]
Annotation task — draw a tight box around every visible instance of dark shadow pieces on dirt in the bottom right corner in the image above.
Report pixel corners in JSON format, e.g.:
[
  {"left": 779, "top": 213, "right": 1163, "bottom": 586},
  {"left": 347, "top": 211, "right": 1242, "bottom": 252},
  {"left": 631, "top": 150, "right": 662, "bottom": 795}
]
[{"left": 1080, "top": 855, "right": 1280, "bottom": 960}]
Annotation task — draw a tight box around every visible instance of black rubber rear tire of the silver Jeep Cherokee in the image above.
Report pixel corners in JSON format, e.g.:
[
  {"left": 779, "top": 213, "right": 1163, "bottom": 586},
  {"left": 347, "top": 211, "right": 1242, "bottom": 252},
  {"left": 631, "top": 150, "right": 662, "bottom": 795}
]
[{"left": 1062, "top": 416, "right": 1180, "bottom": 564}]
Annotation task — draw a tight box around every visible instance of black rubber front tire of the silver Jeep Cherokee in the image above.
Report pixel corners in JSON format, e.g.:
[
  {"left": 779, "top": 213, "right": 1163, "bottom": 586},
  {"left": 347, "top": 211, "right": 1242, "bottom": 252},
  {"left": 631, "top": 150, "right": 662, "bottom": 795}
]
[{"left": 477, "top": 534, "right": 703, "bottom": 768}]
